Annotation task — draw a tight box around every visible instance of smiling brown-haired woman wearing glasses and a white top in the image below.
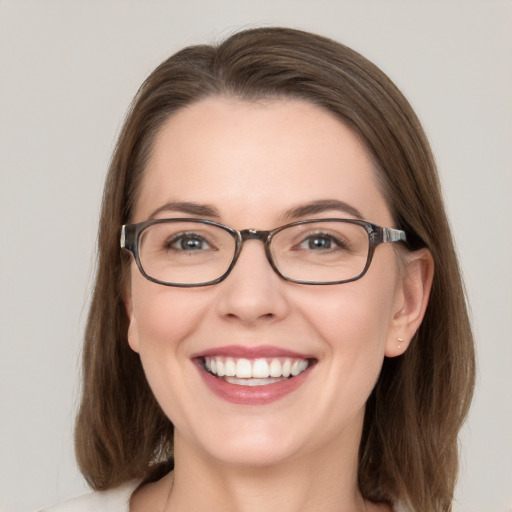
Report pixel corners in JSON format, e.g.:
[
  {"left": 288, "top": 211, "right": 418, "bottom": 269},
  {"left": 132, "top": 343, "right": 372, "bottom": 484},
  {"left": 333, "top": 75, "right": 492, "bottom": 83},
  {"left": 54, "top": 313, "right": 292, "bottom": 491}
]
[{"left": 46, "top": 28, "right": 474, "bottom": 512}]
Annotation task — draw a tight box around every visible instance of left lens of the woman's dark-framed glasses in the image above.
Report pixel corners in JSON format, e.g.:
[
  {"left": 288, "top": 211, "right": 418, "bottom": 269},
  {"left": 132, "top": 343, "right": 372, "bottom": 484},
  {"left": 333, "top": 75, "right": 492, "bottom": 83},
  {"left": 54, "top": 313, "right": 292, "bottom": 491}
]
[{"left": 139, "top": 221, "right": 236, "bottom": 285}]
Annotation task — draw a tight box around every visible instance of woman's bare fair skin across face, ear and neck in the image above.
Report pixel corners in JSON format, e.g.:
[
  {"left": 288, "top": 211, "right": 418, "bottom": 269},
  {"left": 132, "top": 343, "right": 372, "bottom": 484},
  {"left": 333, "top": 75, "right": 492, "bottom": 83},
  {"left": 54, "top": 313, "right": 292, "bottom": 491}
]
[{"left": 125, "top": 98, "right": 432, "bottom": 512}]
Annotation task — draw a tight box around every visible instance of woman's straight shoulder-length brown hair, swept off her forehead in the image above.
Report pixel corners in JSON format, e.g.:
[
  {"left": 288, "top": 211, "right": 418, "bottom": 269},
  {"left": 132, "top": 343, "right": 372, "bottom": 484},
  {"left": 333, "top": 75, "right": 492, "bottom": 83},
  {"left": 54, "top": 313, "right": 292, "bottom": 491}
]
[{"left": 76, "top": 28, "right": 474, "bottom": 512}]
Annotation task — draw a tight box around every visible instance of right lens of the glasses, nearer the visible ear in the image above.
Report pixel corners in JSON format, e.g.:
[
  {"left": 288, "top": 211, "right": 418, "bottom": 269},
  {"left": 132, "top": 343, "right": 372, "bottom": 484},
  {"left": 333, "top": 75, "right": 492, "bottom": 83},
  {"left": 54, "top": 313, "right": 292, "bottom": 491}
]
[{"left": 271, "top": 221, "right": 370, "bottom": 283}]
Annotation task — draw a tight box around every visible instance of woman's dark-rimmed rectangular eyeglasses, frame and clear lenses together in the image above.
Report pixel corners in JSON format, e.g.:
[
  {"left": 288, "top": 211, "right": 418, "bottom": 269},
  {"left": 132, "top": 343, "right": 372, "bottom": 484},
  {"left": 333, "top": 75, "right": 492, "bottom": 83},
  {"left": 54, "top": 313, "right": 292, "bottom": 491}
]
[{"left": 121, "top": 218, "right": 406, "bottom": 287}]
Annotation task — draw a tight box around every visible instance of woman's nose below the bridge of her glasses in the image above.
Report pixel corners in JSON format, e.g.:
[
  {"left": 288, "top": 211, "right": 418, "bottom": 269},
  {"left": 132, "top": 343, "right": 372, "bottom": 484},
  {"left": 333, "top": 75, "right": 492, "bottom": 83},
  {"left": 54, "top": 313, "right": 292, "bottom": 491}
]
[{"left": 216, "top": 237, "right": 291, "bottom": 324}]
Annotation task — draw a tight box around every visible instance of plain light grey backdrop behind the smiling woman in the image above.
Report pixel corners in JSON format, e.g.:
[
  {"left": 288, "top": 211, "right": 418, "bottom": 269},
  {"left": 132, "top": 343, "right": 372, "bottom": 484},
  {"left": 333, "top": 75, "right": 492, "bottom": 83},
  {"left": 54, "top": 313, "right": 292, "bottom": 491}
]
[{"left": 0, "top": 0, "right": 512, "bottom": 512}]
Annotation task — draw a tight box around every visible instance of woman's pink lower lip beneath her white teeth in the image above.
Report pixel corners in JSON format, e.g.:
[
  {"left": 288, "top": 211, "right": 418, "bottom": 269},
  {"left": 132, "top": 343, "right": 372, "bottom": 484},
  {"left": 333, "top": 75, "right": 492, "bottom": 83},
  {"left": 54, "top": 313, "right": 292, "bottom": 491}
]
[{"left": 197, "top": 364, "right": 312, "bottom": 405}]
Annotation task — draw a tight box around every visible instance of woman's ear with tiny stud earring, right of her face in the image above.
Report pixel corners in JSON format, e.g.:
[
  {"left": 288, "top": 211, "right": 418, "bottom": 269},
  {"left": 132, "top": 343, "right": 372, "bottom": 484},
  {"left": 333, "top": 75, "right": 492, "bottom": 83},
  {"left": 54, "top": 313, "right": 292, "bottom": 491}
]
[{"left": 385, "top": 249, "right": 434, "bottom": 357}]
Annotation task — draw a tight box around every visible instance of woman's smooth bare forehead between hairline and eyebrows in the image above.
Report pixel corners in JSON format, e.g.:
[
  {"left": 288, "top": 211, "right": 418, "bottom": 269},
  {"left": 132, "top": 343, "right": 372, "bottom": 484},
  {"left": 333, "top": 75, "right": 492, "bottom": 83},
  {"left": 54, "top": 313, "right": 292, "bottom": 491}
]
[{"left": 135, "top": 97, "right": 389, "bottom": 227}]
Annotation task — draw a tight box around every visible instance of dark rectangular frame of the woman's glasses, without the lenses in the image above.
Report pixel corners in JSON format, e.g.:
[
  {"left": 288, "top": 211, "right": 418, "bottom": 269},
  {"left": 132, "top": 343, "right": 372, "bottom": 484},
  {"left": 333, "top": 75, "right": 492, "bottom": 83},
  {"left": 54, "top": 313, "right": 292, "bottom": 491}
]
[{"left": 120, "top": 218, "right": 407, "bottom": 288}]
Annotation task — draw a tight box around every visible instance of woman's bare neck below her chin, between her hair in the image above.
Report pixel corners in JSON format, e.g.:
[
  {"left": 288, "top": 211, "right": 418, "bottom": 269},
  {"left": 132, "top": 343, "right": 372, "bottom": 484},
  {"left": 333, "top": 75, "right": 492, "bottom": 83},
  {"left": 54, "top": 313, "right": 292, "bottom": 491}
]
[{"left": 163, "top": 428, "right": 370, "bottom": 512}]
